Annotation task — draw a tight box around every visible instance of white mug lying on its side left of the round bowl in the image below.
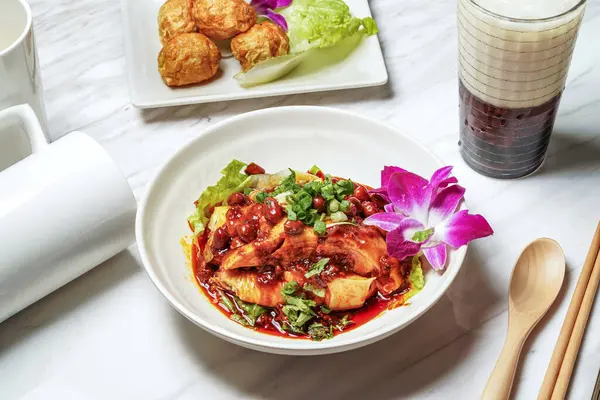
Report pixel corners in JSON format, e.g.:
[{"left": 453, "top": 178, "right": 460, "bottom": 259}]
[{"left": 0, "top": 104, "right": 137, "bottom": 322}]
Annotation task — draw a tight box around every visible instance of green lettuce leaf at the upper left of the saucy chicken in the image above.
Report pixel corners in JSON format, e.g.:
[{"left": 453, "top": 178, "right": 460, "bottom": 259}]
[{"left": 188, "top": 160, "right": 252, "bottom": 235}]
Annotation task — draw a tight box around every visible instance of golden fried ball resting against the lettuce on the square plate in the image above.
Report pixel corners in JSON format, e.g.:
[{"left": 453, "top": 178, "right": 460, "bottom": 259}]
[{"left": 231, "top": 21, "right": 290, "bottom": 72}]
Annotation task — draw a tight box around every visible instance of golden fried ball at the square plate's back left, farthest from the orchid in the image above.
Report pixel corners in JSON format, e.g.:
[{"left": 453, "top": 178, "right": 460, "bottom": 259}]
[{"left": 158, "top": 0, "right": 197, "bottom": 45}]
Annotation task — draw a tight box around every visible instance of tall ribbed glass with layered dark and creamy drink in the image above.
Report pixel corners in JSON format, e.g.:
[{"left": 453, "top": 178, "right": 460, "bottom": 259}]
[{"left": 457, "top": 0, "right": 585, "bottom": 178}]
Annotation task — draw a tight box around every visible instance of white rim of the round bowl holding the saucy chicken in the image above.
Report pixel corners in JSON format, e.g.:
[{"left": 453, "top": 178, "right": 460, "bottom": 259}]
[{"left": 135, "top": 106, "right": 468, "bottom": 355}]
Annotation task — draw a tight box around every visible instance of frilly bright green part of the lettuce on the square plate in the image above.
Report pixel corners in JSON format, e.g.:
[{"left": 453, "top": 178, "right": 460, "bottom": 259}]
[{"left": 281, "top": 0, "right": 377, "bottom": 54}]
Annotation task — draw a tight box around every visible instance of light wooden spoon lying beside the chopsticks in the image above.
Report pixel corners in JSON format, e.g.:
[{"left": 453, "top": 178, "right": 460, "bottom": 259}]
[{"left": 481, "top": 238, "right": 565, "bottom": 400}]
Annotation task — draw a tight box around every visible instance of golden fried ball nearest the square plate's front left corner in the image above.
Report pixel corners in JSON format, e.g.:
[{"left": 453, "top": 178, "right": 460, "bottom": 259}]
[{"left": 158, "top": 33, "right": 221, "bottom": 86}]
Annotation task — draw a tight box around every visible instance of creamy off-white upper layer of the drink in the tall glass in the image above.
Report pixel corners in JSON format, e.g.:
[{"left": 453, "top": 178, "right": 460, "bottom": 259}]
[{"left": 458, "top": 0, "right": 584, "bottom": 108}]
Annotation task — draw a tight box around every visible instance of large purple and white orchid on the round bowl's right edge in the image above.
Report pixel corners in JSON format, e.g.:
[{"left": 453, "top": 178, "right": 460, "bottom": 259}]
[{"left": 364, "top": 166, "right": 494, "bottom": 270}]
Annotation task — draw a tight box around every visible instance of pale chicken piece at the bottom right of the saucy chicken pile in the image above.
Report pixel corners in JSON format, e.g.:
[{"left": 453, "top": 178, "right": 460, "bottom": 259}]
[{"left": 325, "top": 275, "right": 377, "bottom": 310}]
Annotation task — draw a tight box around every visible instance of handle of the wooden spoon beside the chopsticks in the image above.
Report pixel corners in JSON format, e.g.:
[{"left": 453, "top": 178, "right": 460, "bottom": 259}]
[{"left": 481, "top": 327, "right": 527, "bottom": 400}]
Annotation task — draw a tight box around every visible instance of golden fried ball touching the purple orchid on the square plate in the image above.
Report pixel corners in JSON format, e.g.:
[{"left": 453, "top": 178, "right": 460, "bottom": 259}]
[{"left": 192, "top": 0, "right": 256, "bottom": 40}]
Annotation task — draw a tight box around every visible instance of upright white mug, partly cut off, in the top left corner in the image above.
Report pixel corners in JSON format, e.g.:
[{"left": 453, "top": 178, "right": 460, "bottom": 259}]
[{"left": 0, "top": 0, "right": 48, "bottom": 132}]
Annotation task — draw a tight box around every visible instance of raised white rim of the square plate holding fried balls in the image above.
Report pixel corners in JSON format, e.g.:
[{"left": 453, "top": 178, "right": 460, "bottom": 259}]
[{"left": 121, "top": 0, "right": 389, "bottom": 110}]
